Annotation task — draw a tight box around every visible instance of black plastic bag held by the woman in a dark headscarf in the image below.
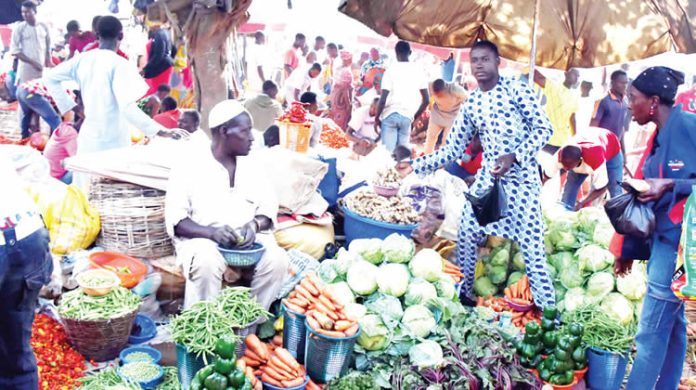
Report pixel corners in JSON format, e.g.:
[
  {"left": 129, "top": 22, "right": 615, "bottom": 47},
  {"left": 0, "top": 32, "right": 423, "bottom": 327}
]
[{"left": 604, "top": 186, "right": 655, "bottom": 239}]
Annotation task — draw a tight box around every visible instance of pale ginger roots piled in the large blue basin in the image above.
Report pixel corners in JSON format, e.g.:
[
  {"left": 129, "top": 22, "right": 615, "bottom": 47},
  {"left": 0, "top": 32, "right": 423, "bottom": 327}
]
[{"left": 342, "top": 190, "right": 421, "bottom": 225}]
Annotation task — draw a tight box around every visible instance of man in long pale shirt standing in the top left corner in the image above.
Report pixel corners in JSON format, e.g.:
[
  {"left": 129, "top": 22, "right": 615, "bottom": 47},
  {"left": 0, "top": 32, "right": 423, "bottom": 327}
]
[{"left": 10, "top": 1, "right": 52, "bottom": 85}]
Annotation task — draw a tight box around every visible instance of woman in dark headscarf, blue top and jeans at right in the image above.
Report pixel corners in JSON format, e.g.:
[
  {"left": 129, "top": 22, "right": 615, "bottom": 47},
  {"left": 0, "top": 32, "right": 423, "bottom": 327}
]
[{"left": 612, "top": 66, "right": 696, "bottom": 390}]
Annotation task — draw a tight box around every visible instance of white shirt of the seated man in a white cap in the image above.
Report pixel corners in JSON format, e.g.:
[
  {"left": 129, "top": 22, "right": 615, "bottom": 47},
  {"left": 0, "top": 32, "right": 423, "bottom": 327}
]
[{"left": 164, "top": 145, "right": 278, "bottom": 238}]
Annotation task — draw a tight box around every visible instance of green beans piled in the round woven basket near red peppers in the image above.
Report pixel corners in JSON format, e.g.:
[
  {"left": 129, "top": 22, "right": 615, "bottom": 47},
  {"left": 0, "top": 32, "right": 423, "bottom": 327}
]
[{"left": 58, "top": 287, "right": 141, "bottom": 321}]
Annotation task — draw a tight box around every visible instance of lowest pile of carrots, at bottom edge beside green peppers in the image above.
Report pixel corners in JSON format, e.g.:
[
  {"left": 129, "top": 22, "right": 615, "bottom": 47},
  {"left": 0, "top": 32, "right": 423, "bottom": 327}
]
[{"left": 240, "top": 334, "right": 320, "bottom": 390}]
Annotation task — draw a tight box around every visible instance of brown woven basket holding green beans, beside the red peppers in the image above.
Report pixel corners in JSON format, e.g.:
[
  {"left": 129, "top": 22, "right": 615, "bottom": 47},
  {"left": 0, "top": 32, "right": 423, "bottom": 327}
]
[{"left": 61, "top": 309, "right": 138, "bottom": 362}]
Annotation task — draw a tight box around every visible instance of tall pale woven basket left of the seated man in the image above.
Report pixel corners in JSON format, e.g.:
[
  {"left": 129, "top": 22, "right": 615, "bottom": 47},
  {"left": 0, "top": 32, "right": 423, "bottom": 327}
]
[{"left": 89, "top": 178, "right": 174, "bottom": 258}]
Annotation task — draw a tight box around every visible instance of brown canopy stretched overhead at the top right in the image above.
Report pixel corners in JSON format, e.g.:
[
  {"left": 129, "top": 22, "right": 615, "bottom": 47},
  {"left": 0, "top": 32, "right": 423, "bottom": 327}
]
[{"left": 339, "top": 0, "right": 696, "bottom": 69}]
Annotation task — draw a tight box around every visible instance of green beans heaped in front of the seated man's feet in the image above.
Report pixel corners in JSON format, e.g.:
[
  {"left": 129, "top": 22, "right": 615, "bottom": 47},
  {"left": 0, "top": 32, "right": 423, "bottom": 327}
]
[{"left": 169, "top": 287, "right": 269, "bottom": 362}]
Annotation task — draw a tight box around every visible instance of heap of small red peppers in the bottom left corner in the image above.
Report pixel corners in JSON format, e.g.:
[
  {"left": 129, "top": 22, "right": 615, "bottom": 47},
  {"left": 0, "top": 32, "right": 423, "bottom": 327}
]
[{"left": 31, "top": 314, "right": 85, "bottom": 390}]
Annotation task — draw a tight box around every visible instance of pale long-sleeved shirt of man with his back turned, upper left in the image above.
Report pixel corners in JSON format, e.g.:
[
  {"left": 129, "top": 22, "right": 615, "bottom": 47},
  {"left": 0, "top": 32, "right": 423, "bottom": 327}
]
[{"left": 43, "top": 49, "right": 162, "bottom": 154}]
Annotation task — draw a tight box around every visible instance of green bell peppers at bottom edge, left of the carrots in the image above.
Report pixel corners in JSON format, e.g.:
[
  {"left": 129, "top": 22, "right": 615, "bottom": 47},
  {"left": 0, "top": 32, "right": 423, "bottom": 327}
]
[{"left": 191, "top": 335, "right": 262, "bottom": 390}]
